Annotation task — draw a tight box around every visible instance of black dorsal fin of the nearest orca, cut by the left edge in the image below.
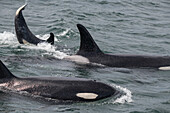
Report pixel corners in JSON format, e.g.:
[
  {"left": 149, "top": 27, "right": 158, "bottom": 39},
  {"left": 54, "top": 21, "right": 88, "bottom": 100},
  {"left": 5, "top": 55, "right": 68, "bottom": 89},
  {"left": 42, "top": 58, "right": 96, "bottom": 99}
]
[{"left": 0, "top": 60, "right": 15, "bottom": 79}]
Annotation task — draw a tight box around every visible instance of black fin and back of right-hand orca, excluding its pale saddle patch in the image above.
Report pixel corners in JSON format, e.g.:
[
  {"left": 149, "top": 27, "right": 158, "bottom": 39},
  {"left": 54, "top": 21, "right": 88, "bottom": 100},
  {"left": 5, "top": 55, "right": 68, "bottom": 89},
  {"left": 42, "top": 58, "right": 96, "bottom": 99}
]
[{"left": 77, "top": 24, "right": 170, "bottom": 68}]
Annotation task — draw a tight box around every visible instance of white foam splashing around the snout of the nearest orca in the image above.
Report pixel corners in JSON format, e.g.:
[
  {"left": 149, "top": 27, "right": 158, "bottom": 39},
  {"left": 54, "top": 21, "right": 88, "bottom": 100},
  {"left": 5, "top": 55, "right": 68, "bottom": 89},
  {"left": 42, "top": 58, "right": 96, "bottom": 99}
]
[{"left": 112, "top": 84, "right": 133, "bottom": 104}]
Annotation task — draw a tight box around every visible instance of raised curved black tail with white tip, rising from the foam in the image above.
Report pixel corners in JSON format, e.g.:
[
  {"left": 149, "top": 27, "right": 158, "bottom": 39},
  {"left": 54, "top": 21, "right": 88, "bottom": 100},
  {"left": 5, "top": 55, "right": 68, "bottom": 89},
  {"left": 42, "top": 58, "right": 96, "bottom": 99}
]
[{"left": 15, "top": 4, "right": 54, "bottom": 45}]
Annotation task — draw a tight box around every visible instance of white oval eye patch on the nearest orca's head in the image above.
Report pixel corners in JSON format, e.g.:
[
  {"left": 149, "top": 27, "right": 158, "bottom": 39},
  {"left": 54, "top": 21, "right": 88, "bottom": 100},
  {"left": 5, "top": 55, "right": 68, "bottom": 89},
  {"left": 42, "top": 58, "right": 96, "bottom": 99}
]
[{"left": 76, "top": 93, "right": 98, "bottom": 100}]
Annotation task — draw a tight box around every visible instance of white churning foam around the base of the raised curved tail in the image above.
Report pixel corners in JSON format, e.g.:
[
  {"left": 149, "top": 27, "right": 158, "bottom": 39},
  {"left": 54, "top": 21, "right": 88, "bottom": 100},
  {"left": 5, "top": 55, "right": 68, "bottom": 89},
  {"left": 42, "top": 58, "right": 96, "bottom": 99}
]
[{"left": 0, "top": 31, "right": 67, "bottom": 59}]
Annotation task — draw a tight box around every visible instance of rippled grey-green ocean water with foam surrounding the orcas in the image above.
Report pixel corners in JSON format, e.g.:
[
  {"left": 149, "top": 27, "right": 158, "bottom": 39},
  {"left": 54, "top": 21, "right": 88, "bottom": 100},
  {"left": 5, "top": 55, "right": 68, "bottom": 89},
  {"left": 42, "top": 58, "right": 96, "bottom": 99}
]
[{"left": 0, "top": 0, "right": 170, "bottom": 113}]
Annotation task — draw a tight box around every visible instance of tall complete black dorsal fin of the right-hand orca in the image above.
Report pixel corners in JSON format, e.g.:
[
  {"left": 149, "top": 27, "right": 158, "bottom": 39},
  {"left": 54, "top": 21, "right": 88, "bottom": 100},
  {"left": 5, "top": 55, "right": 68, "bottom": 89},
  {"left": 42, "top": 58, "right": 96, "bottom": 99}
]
[{"left": 77, "top": 24, "right": 103, "bottom": 55}]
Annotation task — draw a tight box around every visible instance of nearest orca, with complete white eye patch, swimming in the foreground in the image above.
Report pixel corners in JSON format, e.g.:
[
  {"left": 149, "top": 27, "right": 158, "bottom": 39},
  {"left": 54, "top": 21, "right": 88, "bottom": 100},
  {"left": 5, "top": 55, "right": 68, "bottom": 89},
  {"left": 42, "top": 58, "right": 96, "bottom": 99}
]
[{"left": 0, "top": 60, "right": 119, "bottom": 102}]
